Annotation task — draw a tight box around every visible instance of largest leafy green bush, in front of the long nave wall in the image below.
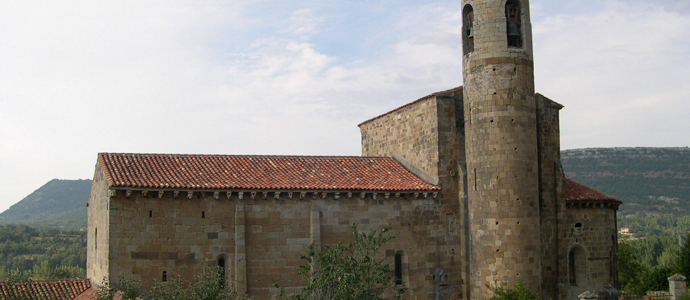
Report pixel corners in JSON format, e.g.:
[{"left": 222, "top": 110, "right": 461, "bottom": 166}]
[{"left": 275, "top": 224, "right": 405, "bottom": 300}]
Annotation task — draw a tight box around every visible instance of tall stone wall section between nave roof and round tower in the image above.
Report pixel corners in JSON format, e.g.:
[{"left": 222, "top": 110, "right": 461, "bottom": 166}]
[{"left": 360, "top": 88, "right": 469, "bottom": 299}]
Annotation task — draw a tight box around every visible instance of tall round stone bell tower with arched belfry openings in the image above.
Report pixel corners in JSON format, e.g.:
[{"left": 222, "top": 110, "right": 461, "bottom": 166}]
[{"left": 462, "top": 0, "right": 542, "bottom": 299}]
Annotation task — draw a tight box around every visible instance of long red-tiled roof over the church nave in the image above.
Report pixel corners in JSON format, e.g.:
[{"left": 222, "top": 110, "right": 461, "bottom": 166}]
[{"left": 98, "top": 153, "right": 440, "bottom": 191}]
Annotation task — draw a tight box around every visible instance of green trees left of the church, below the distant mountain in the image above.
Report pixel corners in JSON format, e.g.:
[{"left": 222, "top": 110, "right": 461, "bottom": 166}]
[{"left": 0, "top": 225, "right": 86, "bottom": 280}]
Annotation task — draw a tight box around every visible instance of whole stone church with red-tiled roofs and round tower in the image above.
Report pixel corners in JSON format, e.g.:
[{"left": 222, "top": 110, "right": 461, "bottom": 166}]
[{"left": 87, "top": 0, "right": 621, "bottom": 299}]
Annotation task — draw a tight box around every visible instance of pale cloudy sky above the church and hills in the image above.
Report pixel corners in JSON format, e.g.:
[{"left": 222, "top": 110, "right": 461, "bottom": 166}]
[{"left": 0, "top": 0, "right": 690, "bottom": 211}]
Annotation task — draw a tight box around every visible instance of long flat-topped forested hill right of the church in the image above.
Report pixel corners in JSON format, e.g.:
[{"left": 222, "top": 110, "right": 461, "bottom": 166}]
[{"left": 561, "top": 147, "right": 690, "bottom": 216}]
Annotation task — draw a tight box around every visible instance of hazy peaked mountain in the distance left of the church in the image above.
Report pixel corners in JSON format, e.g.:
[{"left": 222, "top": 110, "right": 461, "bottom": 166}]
[{"left": 0, "top": 179, "right": 91, "bottom": 229}]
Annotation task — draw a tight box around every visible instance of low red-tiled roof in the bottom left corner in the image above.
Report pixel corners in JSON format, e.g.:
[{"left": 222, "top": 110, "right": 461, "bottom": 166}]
[{"left": 0, "top": 278, "right": 91, "bottom": 299}]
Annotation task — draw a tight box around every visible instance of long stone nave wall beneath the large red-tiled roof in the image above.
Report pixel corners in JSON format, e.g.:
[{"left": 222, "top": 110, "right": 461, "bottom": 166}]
[{"left": 89, "top": 187, "right": 461, "bottom": 299}]
